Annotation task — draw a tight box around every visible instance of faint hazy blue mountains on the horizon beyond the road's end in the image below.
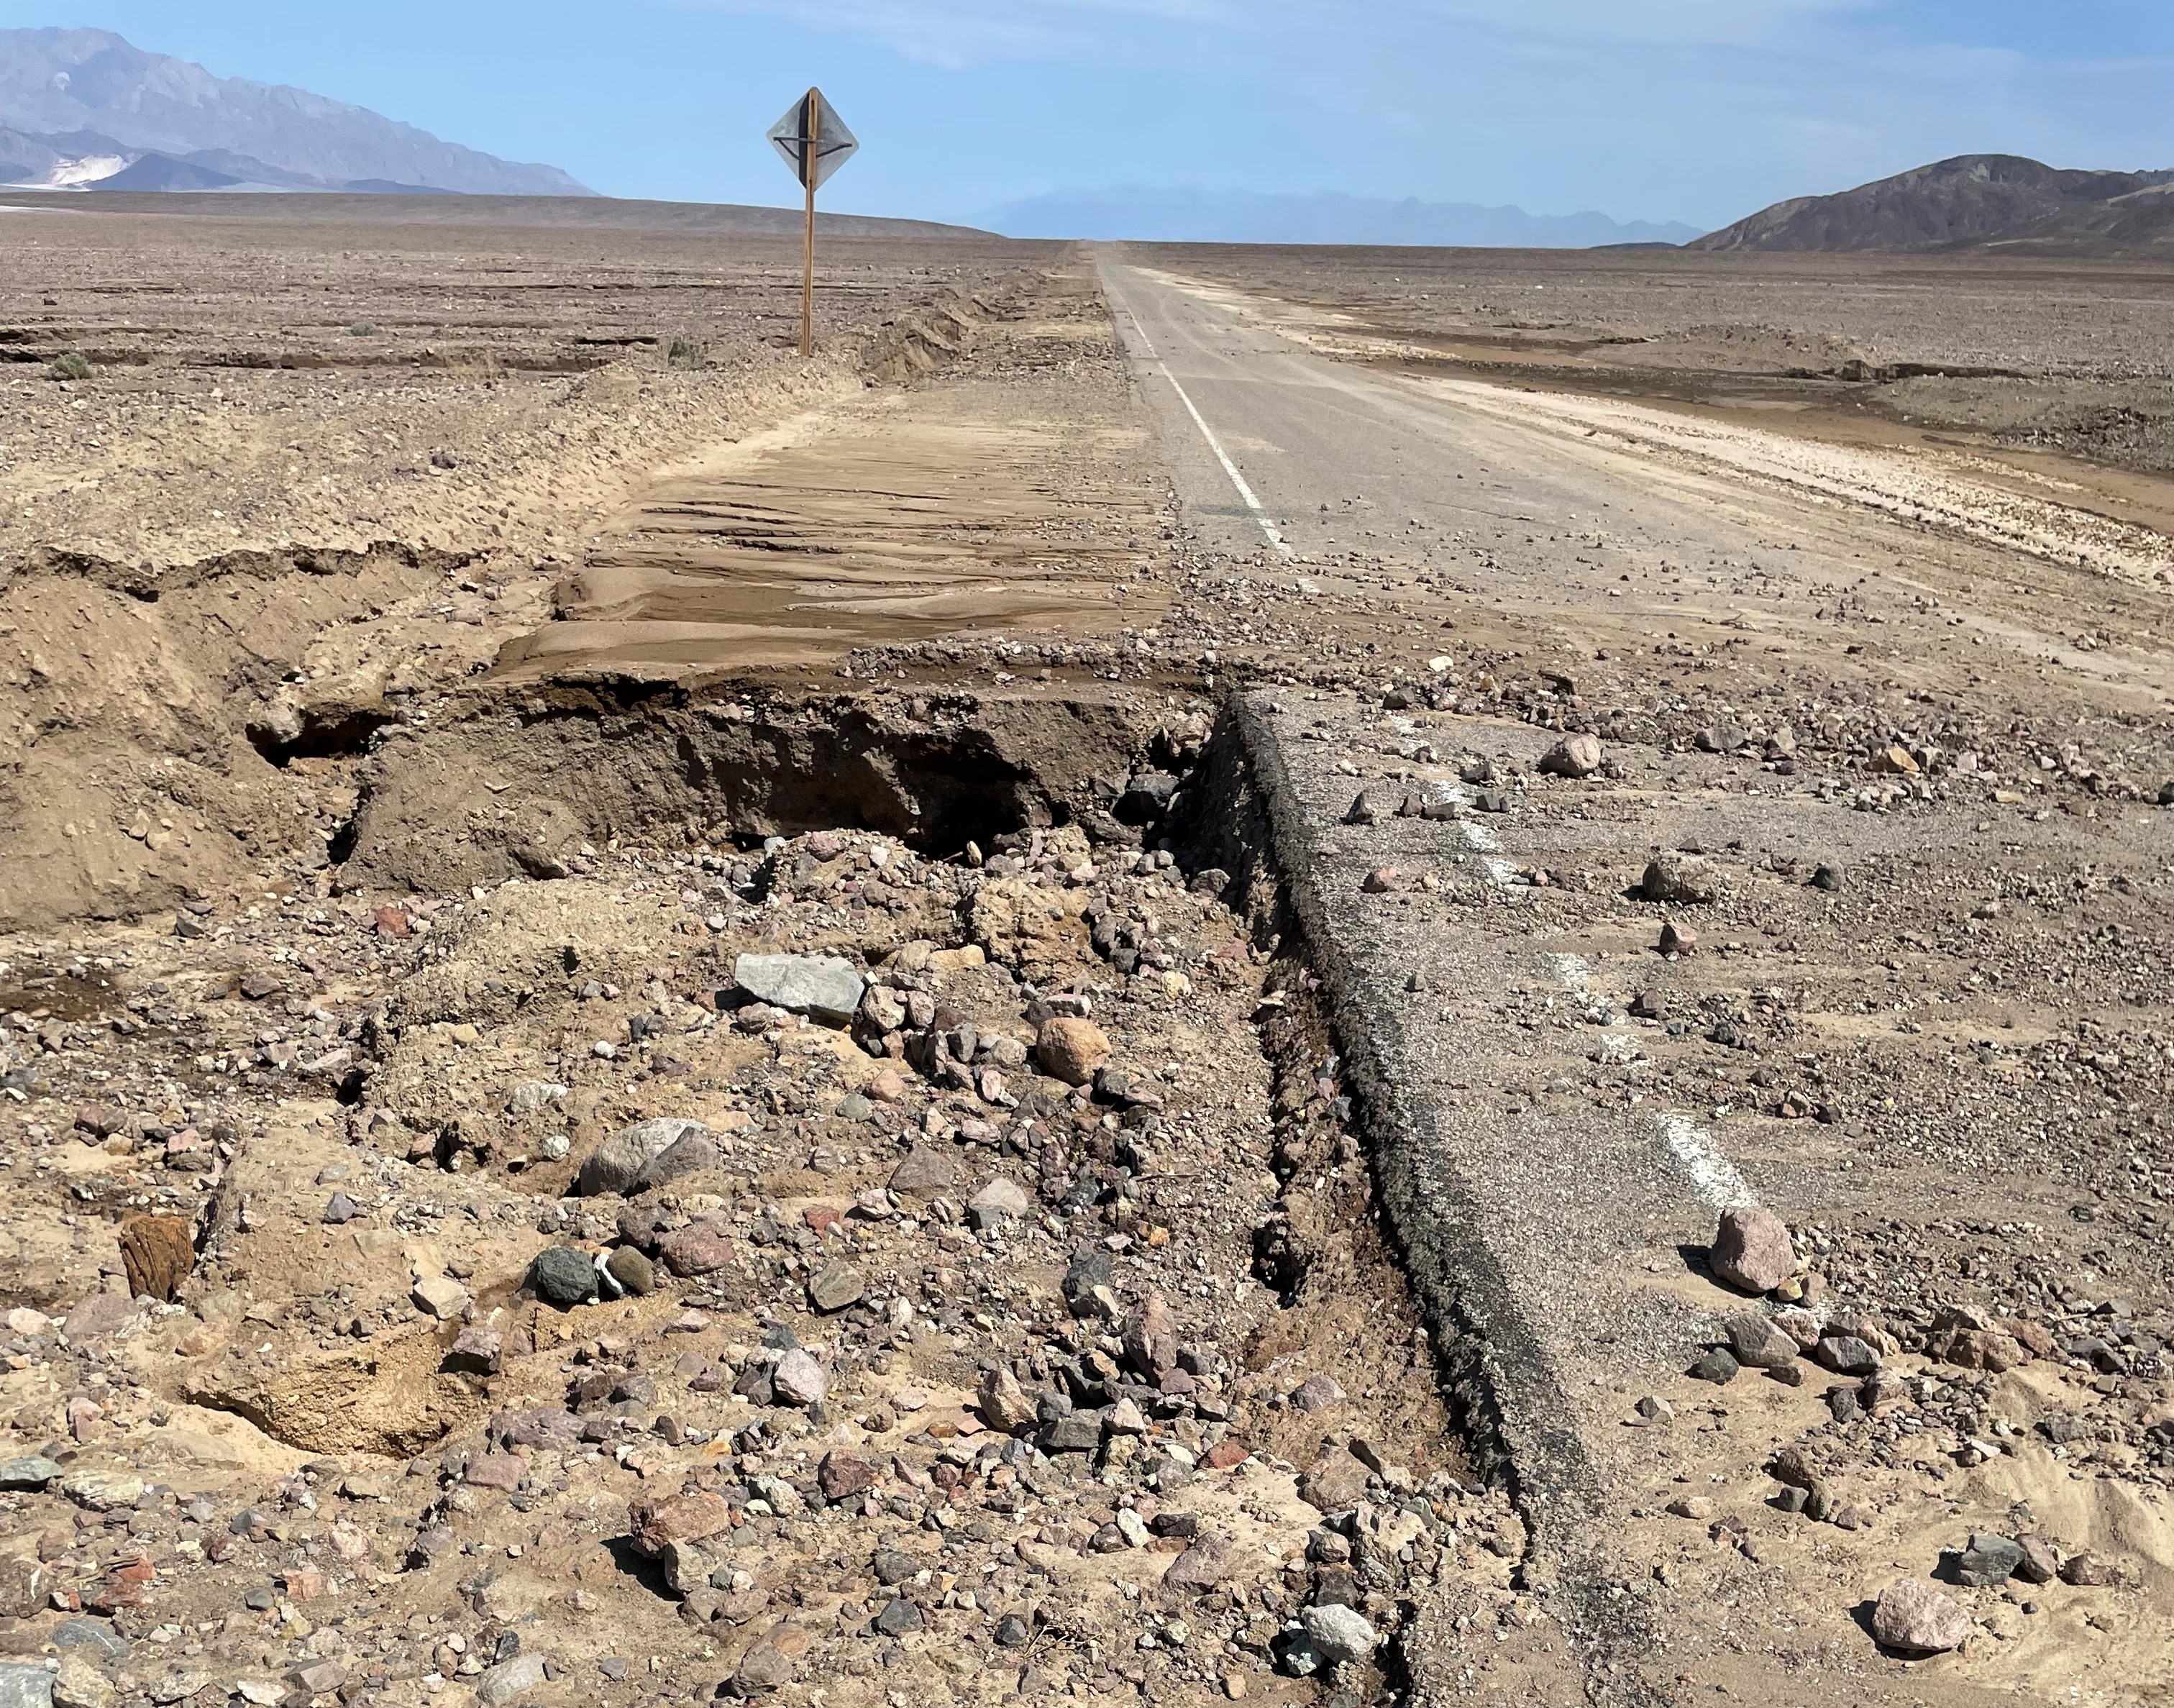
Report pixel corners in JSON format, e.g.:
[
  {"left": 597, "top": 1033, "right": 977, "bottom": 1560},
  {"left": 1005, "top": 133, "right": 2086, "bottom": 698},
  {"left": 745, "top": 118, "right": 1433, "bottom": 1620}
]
[{"left": 974, "top": 189, "right": 1698, "bottom": 250}]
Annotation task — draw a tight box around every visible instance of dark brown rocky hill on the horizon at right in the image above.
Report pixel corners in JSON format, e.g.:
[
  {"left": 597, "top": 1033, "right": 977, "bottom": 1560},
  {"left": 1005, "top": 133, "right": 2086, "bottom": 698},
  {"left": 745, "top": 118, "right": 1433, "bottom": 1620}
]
[{"left": 1691, "top": 155, "right": 2174, "bottom": 252}]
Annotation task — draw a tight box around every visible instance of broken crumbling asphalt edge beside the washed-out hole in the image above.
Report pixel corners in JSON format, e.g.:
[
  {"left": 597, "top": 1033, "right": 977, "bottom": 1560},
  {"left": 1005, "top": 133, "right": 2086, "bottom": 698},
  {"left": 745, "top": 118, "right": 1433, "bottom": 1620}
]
[{"left": 1196, "top": 687, "right": 1659, "bottom": 1708}]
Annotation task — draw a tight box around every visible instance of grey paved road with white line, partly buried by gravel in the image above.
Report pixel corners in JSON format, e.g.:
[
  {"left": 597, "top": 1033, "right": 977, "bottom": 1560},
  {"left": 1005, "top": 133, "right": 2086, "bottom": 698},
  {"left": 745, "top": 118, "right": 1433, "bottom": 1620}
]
[{"left": 1102, "top": 261, "right": 2142, "bottom": 1702}]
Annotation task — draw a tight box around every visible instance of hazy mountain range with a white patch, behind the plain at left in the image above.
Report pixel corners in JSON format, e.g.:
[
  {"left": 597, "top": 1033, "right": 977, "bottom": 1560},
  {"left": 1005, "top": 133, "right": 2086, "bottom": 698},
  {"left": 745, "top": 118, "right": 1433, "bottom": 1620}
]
[{"left": 0, "top": 30, "right": 591, "bottom": 196}]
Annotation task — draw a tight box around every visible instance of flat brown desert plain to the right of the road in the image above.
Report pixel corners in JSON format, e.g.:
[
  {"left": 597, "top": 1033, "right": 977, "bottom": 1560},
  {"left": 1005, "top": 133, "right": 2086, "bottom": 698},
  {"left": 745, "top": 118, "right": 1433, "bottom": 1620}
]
[{"left": 1124, "top": 243, "right": 2174, "bottom": 528}]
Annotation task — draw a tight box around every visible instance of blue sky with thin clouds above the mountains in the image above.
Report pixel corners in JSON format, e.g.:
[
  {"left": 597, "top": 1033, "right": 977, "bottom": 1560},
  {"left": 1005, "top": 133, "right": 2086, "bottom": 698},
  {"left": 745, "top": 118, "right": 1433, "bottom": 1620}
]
[{"left": 17, "top": 0, "right": 2174, "bottom": 226}]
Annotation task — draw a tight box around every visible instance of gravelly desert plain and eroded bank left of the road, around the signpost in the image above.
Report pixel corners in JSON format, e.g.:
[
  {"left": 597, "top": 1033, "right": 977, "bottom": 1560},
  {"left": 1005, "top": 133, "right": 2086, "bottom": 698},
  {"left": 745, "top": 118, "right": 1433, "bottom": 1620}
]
[{"left": 0, "top": 213, "right": 1137, "bottom": 923}]
